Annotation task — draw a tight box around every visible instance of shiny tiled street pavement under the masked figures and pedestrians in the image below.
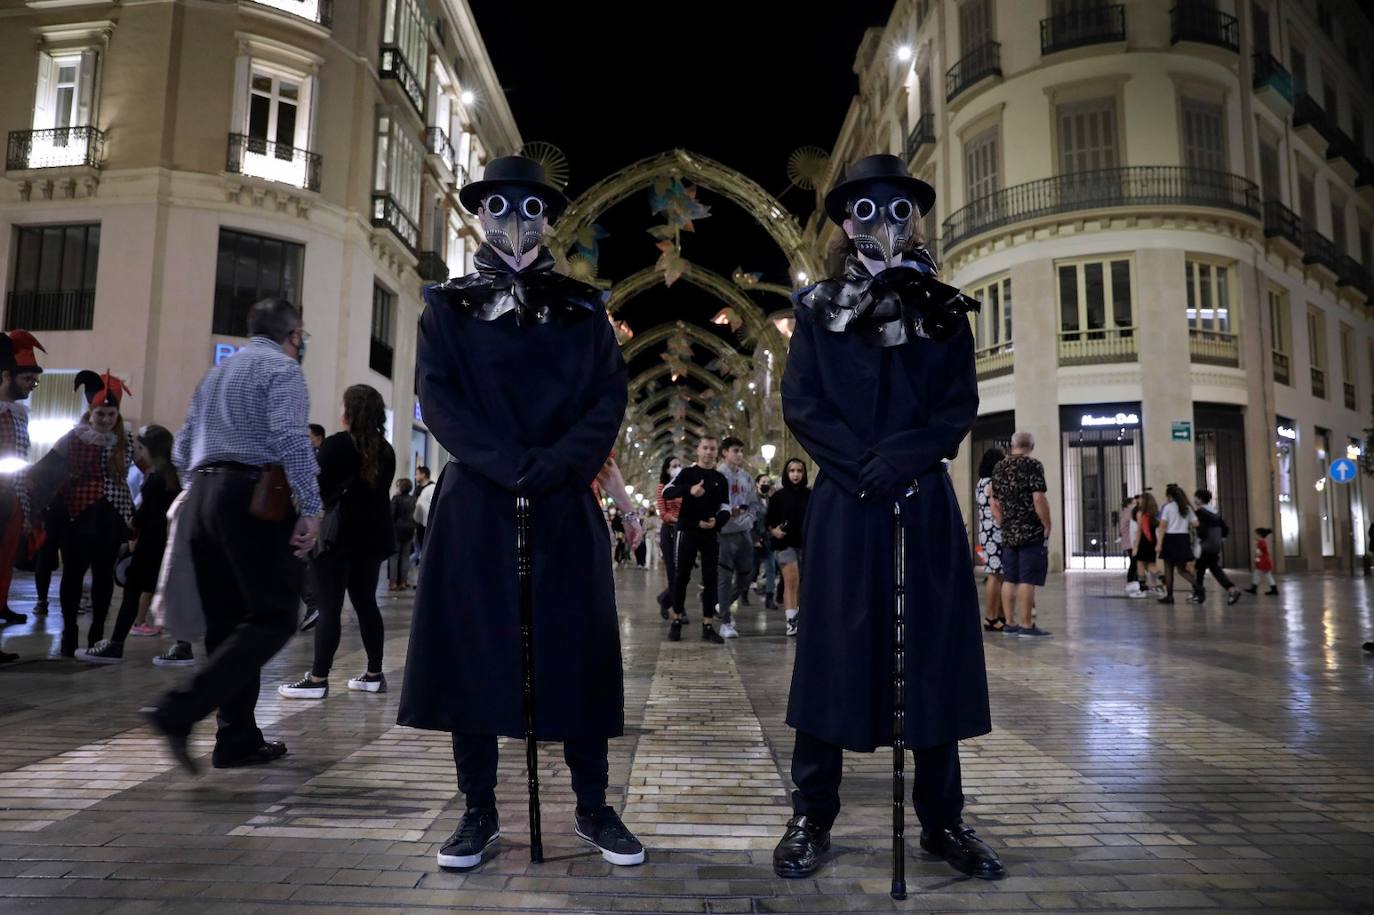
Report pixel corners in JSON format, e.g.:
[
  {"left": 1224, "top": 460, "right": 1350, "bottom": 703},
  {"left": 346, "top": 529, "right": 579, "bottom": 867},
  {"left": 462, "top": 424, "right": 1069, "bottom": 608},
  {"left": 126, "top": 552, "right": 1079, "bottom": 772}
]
[{"left": 0, "top": 569, "right": 1374, "bottom": 912}]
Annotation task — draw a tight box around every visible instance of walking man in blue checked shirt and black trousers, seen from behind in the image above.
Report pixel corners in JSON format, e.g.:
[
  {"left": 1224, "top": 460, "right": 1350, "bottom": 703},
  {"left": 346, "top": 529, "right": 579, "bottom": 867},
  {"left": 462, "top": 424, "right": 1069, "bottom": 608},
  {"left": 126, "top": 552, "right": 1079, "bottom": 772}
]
[{"left": 148, "top": 298, "right": 320, "bottom": 773}]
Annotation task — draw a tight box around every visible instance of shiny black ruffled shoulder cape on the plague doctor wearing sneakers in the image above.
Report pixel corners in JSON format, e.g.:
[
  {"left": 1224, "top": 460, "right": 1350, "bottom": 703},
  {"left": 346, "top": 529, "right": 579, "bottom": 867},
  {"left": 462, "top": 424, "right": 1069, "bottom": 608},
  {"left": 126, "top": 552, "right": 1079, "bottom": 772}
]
[{"left": 425, "top": 245, "right": 606, "bottom": 327}]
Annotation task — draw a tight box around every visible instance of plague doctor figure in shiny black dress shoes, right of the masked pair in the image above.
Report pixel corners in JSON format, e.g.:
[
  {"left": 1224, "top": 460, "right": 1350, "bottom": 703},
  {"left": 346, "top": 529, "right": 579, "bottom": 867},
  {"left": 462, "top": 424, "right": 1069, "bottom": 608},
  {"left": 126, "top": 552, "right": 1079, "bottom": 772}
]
[{"left": 774, "top": 155, "right": 1003, "bottom": 878}]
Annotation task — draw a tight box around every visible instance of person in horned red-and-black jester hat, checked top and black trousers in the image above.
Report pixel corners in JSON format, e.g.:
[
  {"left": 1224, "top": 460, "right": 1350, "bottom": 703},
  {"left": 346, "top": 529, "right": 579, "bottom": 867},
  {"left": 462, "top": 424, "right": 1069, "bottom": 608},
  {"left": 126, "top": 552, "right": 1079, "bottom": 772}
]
[{"left": 30, "top": 371, "right": 133, "bottom": 658}]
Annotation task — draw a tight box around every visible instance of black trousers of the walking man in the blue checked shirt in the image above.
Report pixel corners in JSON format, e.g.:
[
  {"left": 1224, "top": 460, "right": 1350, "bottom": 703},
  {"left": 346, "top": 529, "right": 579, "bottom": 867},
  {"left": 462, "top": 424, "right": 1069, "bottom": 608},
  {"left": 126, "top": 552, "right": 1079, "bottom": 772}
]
[{"left": 157, "top": 471, "right": 305, "bottom": 757}]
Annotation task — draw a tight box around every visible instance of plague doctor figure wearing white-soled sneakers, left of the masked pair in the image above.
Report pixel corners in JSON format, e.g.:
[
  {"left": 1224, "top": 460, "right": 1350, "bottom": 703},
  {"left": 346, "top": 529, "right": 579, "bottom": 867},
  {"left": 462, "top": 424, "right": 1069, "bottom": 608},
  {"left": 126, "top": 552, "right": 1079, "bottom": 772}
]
[{"left": 398, "top": 155, "right": 644, "bottom": 867}]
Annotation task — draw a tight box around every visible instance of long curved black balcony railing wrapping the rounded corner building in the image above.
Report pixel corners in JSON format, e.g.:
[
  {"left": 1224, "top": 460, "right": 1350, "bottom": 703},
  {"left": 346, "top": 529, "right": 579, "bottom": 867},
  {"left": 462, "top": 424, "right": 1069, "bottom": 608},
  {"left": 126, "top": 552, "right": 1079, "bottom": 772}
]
[{"left": 941, "top": 165, "right": 1260, "bottom": 250}]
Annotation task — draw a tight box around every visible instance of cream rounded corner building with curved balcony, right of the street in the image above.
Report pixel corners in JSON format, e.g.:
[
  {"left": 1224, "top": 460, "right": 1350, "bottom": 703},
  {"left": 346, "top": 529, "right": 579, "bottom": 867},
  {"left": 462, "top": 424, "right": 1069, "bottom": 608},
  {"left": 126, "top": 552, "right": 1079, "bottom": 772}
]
[{"left": 808, "top": 0, "right": 1374, "bottom": 569}]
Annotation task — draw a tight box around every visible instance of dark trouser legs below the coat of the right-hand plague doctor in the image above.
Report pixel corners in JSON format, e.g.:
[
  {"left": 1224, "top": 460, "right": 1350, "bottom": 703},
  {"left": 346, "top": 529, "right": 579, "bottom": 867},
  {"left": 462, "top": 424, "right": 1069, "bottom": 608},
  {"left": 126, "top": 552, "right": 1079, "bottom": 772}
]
[{"left": 791, "top": 731, "right": 963, "bottom": 830}]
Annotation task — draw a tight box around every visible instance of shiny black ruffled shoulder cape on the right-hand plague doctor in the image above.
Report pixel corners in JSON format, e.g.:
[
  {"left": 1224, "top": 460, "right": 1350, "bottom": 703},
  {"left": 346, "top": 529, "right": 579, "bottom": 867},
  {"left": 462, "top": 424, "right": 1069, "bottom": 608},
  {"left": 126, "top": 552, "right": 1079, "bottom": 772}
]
[{"left": 796, "top": 249, "right": 982, "bottom": 346}]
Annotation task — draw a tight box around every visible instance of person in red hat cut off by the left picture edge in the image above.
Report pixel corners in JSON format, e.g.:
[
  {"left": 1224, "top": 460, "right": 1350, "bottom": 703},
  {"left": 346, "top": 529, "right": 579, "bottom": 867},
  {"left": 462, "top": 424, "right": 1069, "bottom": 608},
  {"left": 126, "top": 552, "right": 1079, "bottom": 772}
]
[{"left": 0, "top": 330, "right": 48, "bottom": 640}]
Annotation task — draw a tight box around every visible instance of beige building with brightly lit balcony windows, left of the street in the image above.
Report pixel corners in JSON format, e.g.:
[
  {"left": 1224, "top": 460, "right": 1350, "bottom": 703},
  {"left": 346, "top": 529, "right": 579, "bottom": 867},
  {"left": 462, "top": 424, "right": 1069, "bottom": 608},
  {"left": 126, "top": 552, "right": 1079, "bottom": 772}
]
[{"left": 0, "top": 0, "right": 521, "bottom": 475}]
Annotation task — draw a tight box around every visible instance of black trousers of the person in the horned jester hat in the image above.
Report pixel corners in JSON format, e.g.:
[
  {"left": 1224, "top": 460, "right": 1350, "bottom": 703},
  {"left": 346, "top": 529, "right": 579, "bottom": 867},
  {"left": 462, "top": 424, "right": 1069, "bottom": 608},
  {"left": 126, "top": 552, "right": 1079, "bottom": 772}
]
[{"left": 58, "top": 499, "right": 128, "bottom": 654}]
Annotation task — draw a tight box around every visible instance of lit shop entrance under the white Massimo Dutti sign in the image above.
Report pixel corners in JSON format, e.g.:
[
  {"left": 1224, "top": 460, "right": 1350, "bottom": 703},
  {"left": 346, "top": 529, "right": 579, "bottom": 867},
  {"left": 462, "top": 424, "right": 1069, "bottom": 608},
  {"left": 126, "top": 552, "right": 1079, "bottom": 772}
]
[{"left": 1051, "top": 427, "right": 1142, "bottom": 569}]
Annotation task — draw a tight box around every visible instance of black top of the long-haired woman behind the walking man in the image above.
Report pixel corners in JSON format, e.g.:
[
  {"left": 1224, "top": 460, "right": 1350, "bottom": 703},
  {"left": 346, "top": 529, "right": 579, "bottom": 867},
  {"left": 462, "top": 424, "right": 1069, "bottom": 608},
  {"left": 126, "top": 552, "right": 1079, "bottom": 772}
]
[{"left": 317, "top": 431, "right": 396, "bottom": 559}]
